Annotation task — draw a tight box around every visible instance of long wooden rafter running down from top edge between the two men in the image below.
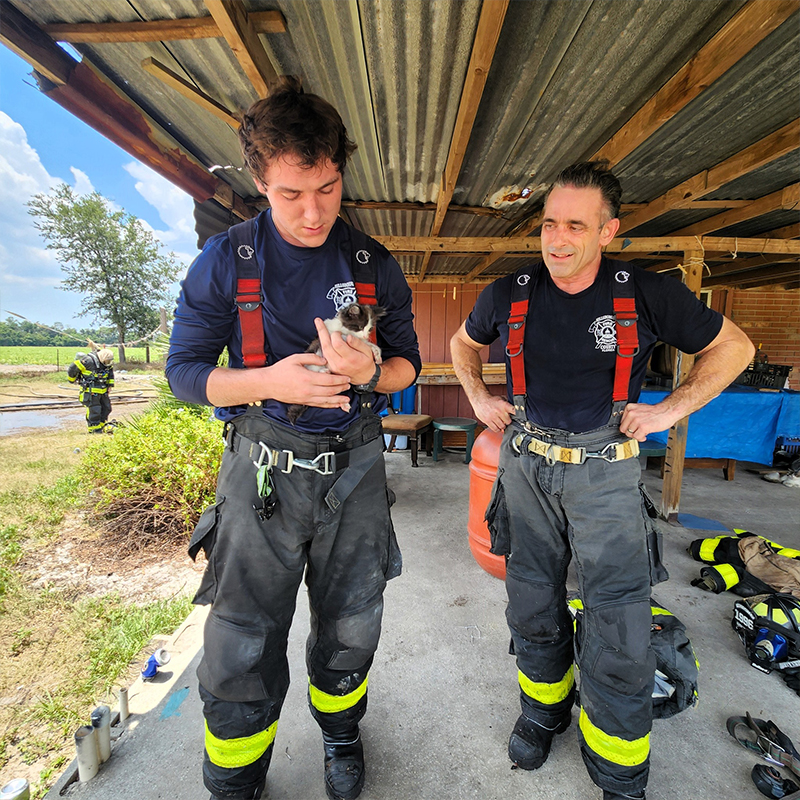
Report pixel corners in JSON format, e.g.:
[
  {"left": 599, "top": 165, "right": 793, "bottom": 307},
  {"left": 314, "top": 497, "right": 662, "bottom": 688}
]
[{"left": 419, "top": 0, "right": 509, "bottom": 280}]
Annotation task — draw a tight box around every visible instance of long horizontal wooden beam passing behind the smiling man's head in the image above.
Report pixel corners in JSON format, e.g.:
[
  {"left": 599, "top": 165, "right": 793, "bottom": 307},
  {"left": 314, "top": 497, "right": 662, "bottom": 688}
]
[{"left": 373, "top": 236, "right": 800, "bottom": 257}]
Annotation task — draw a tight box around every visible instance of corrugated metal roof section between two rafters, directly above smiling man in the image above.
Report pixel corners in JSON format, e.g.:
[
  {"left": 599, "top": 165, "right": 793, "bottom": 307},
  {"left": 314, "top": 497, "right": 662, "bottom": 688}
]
[{"left": 454, "top": 0, "right": 742, "bottom": 211}]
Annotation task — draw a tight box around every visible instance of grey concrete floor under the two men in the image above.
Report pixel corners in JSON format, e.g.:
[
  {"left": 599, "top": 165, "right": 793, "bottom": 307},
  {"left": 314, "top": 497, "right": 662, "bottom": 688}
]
[{"left": 47, "top": 452, "right": 800, "bottom": 800}]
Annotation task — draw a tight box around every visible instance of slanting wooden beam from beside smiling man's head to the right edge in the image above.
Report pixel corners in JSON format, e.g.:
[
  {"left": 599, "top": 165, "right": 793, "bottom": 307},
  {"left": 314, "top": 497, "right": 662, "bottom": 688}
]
[{"left": 619, "top": 119, "right": 800, "bottom": 233}]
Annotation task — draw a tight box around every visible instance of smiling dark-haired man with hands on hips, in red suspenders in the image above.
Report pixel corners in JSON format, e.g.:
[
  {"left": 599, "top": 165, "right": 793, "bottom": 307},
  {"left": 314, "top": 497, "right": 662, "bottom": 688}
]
[{"left": 451, "top": 162, "right": 753, "bottom": 800}]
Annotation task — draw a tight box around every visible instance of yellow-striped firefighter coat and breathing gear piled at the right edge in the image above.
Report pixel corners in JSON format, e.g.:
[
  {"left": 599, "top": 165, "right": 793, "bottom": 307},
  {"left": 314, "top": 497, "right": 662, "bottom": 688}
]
[{"left": 689, "top": 529, "right": 800, "bottom": 695}]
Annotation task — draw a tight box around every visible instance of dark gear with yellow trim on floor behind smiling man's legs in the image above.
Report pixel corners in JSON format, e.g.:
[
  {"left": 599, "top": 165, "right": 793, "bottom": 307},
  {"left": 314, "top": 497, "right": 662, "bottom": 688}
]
[{"left": 568, "top": 593, "right": 700, "bottom": 719}]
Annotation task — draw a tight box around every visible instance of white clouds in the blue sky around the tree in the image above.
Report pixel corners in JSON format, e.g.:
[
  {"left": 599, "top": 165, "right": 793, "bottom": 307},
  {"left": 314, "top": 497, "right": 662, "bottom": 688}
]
[{"left": 0, "top": 111, "right": 197, "bottom": 327}]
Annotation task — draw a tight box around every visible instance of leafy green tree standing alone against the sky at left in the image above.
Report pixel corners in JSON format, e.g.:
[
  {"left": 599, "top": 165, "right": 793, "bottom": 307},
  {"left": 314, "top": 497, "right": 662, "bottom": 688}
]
[{"left": 27, "top": 183, "right": 181, "bottom": 361}]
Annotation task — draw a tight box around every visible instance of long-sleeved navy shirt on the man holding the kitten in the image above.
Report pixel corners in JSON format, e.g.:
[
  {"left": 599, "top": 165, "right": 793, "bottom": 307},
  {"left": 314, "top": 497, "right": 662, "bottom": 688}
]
[{"left": 166, "top": 211, "right": 421, "bottom": 433}]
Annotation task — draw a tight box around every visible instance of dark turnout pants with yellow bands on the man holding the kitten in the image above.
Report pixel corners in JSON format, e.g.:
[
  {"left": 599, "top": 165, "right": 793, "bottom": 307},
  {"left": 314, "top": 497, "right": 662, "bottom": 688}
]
[{"left": 190, "top": 409, "right": 401, "bottom": 798}]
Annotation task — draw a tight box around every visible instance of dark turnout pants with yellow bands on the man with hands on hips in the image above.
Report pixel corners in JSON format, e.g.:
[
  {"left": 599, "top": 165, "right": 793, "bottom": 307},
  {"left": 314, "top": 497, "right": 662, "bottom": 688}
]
[{"left": 487, "top": 425, "right": 656, "bottom": 793}]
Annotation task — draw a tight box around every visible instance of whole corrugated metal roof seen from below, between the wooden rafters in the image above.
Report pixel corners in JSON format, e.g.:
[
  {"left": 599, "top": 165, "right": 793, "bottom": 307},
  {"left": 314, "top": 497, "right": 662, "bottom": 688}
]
[{"left": 4, "top": 0, "right": 800, "bottom": 288}]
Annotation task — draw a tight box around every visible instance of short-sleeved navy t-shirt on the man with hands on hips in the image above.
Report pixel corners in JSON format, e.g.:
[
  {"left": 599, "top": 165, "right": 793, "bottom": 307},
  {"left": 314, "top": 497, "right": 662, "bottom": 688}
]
[{"left": 466, "top": 256, "right": 722, "bottom": 433}]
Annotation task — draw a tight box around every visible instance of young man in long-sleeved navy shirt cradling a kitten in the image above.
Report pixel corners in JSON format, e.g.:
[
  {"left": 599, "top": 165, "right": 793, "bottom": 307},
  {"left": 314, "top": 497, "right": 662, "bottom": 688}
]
[{"left": 167, "top": 76, "right": 421, "bottom": 800}]
